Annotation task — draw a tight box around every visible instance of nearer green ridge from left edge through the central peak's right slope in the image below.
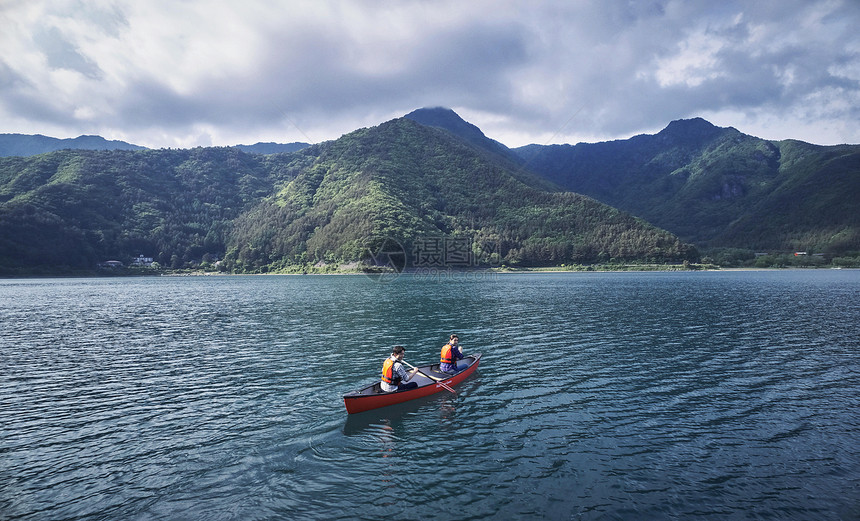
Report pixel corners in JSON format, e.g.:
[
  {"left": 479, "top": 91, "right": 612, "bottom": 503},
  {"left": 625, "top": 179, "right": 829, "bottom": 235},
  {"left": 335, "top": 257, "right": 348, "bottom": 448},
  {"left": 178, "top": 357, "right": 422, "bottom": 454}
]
[{"left": 0, "top": 118, "right": 697, "bottom": 274}]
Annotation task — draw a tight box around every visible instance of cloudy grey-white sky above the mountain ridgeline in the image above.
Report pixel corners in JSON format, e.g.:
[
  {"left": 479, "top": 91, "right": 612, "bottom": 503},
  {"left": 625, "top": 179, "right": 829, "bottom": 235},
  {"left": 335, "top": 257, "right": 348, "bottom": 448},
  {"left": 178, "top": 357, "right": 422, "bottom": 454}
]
[{"left": 0, "top": 0, "right": 860, "bottom": 148}]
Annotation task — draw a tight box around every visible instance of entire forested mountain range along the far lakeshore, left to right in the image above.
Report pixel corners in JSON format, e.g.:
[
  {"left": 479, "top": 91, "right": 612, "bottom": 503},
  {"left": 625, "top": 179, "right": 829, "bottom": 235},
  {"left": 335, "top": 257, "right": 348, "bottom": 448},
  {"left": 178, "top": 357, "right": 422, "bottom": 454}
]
[{"left": 8, "top": 109, "right": 860, "bottom": 274}]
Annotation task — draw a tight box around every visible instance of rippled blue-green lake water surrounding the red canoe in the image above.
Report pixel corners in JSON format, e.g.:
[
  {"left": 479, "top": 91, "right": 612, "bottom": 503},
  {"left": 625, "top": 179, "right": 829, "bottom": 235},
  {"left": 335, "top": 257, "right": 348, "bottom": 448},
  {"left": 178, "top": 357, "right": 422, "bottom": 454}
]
[{"left": 0, "top": 270, "right": 860, "bottom": 521}]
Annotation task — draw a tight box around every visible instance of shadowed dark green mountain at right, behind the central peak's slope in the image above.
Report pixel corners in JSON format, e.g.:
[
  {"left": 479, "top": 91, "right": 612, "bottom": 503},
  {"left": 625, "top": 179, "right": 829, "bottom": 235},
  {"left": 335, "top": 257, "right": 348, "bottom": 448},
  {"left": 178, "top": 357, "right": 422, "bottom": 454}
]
[{"left": 515, "top": 118, "right": 860, "bottom": 254}]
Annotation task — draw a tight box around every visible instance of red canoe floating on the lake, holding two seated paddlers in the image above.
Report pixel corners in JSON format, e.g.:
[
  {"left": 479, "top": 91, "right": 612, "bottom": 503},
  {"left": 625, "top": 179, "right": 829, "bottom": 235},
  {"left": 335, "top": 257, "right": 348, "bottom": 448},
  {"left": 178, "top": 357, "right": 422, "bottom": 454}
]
[{"left": 343, "top": 353, "right": 481, "bottom": 414}]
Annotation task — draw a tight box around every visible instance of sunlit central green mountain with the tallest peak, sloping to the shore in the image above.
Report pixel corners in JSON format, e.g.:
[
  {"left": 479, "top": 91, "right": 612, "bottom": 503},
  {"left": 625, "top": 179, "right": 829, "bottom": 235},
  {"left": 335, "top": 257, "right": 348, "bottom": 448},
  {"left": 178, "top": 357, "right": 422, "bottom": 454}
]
[{"left": 225, "top": 118, "right": 696, "bottom": 271}]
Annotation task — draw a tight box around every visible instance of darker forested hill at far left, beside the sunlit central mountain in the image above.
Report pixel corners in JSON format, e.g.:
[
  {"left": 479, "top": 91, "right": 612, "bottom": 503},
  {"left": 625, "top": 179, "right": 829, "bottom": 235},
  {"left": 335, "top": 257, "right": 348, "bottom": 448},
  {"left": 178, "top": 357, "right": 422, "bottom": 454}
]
[{"left": 0, "top": 148, "right": 290, "bottom": 273}]
